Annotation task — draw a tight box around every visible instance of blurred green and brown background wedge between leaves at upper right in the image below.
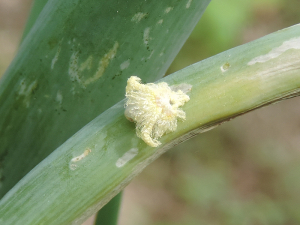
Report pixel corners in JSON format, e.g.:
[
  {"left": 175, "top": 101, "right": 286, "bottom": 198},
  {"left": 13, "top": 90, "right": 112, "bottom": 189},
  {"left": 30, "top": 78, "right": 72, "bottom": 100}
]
[{"left": 168, "top": 0, "right": 300, "bottom": 73}]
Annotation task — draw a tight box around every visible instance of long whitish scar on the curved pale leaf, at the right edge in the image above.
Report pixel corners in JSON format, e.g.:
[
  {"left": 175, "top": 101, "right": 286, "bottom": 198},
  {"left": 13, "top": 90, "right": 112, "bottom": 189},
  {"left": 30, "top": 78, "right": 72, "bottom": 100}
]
[{"left": 247, "top": 37, "right": 300, "bottom": 66}]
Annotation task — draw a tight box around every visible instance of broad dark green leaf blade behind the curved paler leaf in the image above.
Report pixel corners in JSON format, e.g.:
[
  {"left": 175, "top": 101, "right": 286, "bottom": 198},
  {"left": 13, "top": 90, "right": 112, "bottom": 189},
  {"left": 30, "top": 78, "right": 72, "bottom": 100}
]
[{"left": 0, "top": 0, "right": 209, "bottom": 197}]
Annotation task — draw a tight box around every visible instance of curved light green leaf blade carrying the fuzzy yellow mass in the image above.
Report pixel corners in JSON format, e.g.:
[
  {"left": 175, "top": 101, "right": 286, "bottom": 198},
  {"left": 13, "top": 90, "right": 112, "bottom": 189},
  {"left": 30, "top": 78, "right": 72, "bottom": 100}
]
[{"left": 0, "top": 25, "right": 300, "bottom": 225}]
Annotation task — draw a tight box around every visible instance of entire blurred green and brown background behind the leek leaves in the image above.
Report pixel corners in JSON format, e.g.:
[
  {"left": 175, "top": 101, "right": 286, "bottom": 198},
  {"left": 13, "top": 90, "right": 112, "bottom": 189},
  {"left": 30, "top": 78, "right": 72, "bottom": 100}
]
[{"left": 0, "top": 0, "right": 300, "bottom": 225}]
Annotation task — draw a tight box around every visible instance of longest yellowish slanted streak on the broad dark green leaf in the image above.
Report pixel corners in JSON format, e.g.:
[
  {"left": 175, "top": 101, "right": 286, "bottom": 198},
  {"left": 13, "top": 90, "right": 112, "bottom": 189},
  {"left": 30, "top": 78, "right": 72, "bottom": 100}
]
[{"left": 84, "top": 42, "right": 119, "bottom": 86}]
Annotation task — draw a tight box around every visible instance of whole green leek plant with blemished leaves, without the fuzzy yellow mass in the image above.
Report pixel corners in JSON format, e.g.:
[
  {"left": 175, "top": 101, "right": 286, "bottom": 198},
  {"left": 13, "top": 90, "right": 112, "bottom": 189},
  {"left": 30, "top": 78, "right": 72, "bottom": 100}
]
[{"left": 0, "top": 0, "right": 300, "bottom": 224}]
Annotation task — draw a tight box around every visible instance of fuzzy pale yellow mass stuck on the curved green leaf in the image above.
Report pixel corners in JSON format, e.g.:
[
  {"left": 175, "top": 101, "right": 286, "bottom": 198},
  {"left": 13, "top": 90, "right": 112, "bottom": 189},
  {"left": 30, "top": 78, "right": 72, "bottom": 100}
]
[{"left": 125, "top": 76, "right": 190, "bottom": 147}]
